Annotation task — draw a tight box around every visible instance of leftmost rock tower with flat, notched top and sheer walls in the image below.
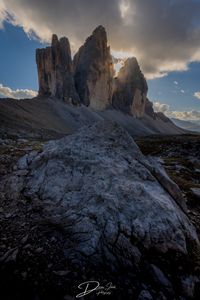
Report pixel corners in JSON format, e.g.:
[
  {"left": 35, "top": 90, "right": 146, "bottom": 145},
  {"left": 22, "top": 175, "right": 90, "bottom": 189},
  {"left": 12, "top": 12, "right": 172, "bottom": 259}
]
[{"left": 36, "top": 34, "right": 79, "bottom": 104}]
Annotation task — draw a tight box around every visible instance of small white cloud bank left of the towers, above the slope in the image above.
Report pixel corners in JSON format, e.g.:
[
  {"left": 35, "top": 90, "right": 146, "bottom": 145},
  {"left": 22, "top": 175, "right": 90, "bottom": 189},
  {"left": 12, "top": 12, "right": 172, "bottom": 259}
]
[{"left": 0, "top": 84, "right": 37, "bottom": 99}]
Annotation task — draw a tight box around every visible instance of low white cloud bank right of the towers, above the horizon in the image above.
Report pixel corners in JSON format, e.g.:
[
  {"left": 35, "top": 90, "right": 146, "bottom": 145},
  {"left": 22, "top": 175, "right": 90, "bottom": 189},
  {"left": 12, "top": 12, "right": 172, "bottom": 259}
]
[{"left": 153, "top": 101, "right": 200, "bottom": 121}]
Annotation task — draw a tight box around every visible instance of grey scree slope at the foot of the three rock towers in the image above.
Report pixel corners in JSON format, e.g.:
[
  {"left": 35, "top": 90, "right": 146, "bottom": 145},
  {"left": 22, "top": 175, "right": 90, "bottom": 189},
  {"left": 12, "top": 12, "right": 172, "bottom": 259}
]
[{"left": 0, "top": 97, "right": 185, "bottom": 139}]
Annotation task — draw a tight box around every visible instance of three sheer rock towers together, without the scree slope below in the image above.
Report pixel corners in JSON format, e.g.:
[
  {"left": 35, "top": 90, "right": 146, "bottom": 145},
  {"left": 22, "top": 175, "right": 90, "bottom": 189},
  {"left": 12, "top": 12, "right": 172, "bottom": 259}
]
[{"left": 37, "top": 25, "right": 151, "bottom": 117}]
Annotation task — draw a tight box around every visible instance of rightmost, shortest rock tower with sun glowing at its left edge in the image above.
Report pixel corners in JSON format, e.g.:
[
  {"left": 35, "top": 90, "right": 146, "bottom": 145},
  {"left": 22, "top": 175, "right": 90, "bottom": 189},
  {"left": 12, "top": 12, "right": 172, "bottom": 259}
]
[{"left": 112, "top": 57, "right": 148, "bottom": 117}]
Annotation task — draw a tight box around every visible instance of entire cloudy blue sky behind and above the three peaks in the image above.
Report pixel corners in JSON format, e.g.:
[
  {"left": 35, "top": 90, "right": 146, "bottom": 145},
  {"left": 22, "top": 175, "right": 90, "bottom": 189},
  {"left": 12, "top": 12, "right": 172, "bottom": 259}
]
[{"left": 0, "top": 0, "right": 200, "bottom": 120}]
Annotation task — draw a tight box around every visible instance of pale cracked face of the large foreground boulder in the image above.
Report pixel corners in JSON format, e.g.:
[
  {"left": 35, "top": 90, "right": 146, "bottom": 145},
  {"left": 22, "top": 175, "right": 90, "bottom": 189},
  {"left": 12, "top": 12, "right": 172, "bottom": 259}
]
[{"left": 16, "top": 122, "right": 199, "bottom": 268}]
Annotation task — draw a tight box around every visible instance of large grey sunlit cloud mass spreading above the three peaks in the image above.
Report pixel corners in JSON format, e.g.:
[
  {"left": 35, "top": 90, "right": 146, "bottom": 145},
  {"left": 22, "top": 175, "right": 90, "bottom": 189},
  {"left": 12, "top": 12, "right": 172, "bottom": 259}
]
[{"left": 0, "top": 0, "right": 200, "bottom": 78}]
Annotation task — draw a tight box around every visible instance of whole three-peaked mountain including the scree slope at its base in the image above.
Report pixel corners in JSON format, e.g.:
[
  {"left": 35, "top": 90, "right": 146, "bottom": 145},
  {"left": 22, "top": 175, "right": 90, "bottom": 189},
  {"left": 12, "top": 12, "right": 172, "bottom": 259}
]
[{"left": 0, "top": 26, "right": 186, "bottom": 137}]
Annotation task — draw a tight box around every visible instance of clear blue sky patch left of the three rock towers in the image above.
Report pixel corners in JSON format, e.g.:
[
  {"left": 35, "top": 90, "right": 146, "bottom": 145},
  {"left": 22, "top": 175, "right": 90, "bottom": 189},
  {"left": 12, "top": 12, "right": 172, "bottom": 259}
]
[{"left": 0, "top": 23, "right": 44, "bottom": 90}]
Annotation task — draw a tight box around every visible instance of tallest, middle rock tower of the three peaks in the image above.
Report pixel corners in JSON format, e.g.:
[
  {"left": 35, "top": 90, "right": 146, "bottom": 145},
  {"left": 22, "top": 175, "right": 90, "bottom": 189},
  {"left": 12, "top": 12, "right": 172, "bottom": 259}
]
[{"left": 74, "top": 26, "right": 114, "bottom": 110}]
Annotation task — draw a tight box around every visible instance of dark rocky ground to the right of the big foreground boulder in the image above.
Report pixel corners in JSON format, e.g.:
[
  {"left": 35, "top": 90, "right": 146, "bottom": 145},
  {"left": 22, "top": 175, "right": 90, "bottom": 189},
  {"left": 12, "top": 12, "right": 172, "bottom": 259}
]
[{"left": 136, "top": 134, "right": 200, "bottom": 235}]
